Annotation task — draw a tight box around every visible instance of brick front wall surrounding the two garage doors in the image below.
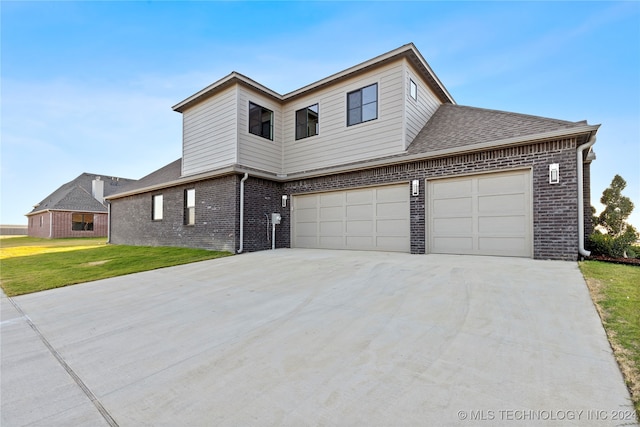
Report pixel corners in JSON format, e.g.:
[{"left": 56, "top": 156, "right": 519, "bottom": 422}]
[{"left": 284, "top": 139, "right": 586, "bottom": 260}]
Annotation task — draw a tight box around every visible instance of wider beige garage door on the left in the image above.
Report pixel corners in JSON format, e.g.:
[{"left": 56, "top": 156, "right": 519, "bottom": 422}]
[{"left": 292, "top": 184, "right": 410, "bottom": 252}]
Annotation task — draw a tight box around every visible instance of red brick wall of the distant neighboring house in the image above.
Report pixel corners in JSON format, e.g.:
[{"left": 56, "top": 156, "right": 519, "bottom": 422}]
[{"left": 28, "top": 211, "right": 108, "bottom": 239}]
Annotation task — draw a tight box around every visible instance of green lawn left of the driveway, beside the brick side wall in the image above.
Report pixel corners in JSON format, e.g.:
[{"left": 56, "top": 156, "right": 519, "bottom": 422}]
[{"left": 0, "top": 238, "right": 231, "bottom": 296}]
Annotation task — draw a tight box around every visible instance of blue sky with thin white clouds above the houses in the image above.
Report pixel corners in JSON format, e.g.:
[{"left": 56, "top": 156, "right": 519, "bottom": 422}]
[{"left": 0, "top": 1, "right": 640, "bottom": 229}]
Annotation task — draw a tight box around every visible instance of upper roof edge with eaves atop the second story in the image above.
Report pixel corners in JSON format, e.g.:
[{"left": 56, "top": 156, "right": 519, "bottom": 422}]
[{"left": 172, "top": 43, "right": 455, "bottom": 113}]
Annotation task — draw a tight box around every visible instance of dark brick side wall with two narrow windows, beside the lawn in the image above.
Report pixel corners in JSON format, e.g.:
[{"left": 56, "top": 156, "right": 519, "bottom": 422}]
[{"left": 110, "top": 175, "right": 239, "bottom": 252}]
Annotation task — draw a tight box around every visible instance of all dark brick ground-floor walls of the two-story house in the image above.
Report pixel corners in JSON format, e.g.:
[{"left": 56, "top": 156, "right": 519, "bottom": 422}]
[{"left": 111, "top": 139, "right": 591, "bottom": 261}]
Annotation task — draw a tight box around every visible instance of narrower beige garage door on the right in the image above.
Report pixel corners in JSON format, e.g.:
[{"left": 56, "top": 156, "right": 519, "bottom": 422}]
[{"left": 427, "top": 170, "right": 533, "bottom": 257}]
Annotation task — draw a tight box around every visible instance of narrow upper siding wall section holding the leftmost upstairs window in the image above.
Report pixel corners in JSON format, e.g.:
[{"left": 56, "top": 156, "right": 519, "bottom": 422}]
[{"left": 238, "top": 87, "right": 282, "bottom": 173}]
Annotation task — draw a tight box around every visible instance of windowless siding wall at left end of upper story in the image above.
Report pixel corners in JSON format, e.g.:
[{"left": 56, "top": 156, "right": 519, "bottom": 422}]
[{"left": 182, "top": 86, "right": 238, "bottom": 175}]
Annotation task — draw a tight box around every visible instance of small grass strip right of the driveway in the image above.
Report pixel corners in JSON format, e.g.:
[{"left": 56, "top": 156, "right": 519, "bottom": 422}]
[{"left": 580, "top": 261, "right": 640, "bottom": 419}]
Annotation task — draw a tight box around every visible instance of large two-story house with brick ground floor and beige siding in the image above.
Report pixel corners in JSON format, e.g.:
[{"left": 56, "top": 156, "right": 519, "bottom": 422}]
[{"left": 107, "top": 44, "right": 599, "bottom": 260}]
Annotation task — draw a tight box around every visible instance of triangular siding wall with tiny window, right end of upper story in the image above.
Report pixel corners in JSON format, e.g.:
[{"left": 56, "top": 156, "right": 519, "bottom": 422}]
[{"left": 404, "top": 61, "right": 441, "bottom": 148}]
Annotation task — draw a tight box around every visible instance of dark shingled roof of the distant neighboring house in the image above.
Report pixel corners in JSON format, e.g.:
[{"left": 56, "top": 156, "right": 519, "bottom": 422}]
[{"left": 27, "top": 172, "right": 135, "bottom": 215}]
